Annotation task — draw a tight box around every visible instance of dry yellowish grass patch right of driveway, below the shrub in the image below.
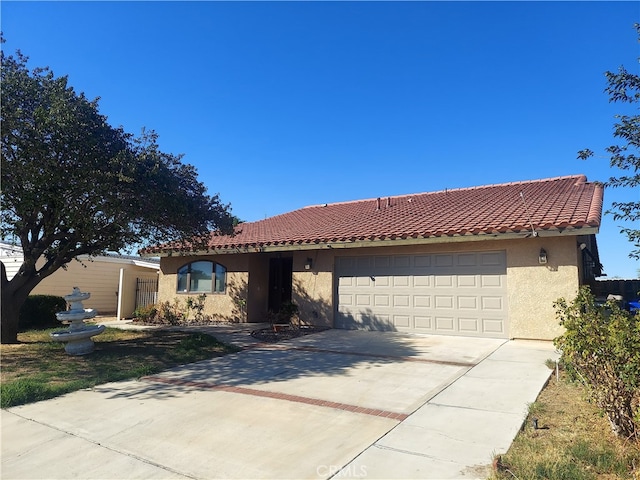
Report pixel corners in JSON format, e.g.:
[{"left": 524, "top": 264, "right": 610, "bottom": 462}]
[{"left": 492, "top": 373, "right": 640, "bottom": 480}]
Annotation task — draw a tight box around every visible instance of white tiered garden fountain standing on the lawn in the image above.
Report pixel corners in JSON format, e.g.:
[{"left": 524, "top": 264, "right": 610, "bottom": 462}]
[{"left": 50, "top": 287, "right": 105, "bottom": 355}]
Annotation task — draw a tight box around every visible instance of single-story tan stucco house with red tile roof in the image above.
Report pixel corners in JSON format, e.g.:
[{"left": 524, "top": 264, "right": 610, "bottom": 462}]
[{"left": 142, "top": 175, "right": 603, "bottom": 339}]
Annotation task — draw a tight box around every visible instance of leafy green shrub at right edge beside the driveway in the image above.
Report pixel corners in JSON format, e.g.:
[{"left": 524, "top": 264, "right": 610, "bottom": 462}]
[{"left": 554, "top": 287, "right": 640, "bottom": 440}]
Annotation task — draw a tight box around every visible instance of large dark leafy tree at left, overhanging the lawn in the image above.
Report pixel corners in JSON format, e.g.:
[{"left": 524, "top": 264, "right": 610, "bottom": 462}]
[{"left": 0, "top": 47, "right": 232, "bottom": 343}]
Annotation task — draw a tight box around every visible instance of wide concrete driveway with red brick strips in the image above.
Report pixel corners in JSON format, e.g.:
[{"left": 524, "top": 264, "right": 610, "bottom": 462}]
[{"left": 1, "top": 327, "right": 556, "bottom": 479}]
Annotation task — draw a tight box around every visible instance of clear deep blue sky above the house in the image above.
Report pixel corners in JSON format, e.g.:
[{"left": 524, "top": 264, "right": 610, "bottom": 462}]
[{"left": 0, "top": 0, "right": 640, "bottom": 278}]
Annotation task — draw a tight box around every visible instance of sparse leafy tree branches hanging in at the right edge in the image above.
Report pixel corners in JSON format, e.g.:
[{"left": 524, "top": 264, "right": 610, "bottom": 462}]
[{"left": 578, "top": 23, "right": 640, "bottom": 259}]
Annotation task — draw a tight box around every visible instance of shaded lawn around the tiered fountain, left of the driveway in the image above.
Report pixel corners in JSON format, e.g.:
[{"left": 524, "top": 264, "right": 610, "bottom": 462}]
[{"left": 0, "top": 328, "right": 238, "bottom": 408}]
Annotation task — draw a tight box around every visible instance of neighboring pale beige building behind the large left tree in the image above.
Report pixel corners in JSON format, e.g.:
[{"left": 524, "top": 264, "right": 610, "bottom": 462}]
[{"left": 0, "top": 243, "right": 160, "bottom": 318}]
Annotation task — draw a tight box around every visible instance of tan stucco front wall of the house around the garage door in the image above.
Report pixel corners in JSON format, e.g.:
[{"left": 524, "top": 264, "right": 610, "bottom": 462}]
[{"left": 159, "top": 236, "right": 579, "bottom": 340}]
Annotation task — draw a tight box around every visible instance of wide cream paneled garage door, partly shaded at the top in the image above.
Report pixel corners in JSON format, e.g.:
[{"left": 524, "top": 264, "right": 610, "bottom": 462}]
[{"left": 335, "top": 251, "right": 507, "bottom": 338}]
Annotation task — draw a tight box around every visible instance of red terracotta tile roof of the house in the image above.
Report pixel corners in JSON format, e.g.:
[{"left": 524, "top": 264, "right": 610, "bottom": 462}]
[{"left": 145, "top": 175, "right": 603, "bottom": 254}]
